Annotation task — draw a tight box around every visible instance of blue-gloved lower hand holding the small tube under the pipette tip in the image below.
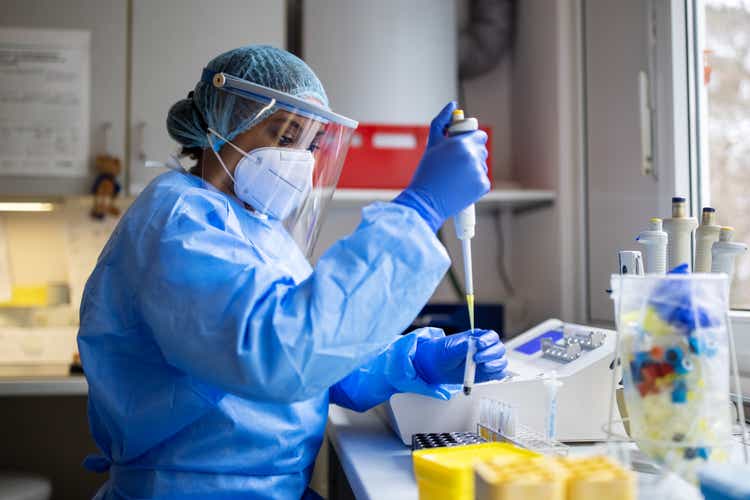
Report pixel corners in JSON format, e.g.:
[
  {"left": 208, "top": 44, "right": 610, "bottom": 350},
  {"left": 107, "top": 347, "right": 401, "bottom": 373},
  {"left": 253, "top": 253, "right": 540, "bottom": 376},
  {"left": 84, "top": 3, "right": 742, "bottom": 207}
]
[{"left": 413, "top": 330, "right": 508, "bottom": 384}]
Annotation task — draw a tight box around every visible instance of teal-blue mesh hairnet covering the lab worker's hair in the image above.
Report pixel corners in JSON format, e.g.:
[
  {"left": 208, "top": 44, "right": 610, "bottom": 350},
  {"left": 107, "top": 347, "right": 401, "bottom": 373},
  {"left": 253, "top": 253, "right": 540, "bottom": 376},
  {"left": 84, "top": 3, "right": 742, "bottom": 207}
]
[{"left": 167, "top": 45, "right": 328, "bottom": 148}]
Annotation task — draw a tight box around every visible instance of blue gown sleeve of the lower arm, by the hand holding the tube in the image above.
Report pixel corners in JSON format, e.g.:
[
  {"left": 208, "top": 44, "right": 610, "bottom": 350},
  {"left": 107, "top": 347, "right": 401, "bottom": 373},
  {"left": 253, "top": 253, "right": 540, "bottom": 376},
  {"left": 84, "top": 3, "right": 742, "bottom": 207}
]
[{"left": 329, "top": 328, "right": 458, "bottom": 412}]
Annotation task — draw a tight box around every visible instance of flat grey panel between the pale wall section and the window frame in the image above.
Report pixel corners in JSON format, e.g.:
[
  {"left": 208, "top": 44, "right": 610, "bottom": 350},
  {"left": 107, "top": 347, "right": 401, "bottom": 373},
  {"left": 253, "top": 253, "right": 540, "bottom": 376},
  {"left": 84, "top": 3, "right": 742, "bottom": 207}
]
[{"left": 584, "top": 0, "right": 659, "bottom": 321}]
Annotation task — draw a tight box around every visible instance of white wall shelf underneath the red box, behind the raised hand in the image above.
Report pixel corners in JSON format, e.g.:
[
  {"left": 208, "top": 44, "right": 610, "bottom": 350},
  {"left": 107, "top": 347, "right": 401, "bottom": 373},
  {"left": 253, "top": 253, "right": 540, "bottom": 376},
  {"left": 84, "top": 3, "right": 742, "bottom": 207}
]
[{"left": 333, "top": 189, "right": 556, "bottom": 211}]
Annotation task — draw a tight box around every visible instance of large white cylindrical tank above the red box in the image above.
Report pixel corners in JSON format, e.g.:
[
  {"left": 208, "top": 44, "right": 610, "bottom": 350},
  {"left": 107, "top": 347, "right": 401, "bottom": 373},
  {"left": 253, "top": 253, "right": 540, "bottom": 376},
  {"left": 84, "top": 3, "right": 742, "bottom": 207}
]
[{"left": 302, "top": 0, "right": 457, "bottom": 124}]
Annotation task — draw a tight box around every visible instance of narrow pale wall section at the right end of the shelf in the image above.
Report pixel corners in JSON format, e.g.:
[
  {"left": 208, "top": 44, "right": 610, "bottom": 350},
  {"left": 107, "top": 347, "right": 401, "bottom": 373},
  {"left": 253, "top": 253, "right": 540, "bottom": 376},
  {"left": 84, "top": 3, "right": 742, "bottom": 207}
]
[{"left": 512, "top": 0, "right": 585, "bottom": 322}]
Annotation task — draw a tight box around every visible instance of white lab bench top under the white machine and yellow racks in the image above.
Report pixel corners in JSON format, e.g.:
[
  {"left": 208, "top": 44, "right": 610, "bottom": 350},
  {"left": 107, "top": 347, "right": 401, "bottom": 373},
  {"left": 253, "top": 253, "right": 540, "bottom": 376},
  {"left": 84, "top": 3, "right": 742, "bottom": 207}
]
[{"left": 327, "top": 406, "right": 742, "bottom": 500}]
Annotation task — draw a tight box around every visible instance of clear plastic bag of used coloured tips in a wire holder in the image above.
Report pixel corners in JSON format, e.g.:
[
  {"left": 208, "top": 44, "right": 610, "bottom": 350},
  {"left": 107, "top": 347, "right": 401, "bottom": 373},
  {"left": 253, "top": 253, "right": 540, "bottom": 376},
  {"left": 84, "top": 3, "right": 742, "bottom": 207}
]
[{"left": 612, "top": 274, "right": 732, "bottom": 482}]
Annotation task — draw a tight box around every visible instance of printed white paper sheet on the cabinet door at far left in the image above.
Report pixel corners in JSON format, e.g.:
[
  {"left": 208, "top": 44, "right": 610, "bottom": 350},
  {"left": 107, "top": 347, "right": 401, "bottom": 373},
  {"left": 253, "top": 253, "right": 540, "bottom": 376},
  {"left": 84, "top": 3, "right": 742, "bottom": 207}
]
[{"left": 0, "top": 28, "right": 91, "bottom": 177}]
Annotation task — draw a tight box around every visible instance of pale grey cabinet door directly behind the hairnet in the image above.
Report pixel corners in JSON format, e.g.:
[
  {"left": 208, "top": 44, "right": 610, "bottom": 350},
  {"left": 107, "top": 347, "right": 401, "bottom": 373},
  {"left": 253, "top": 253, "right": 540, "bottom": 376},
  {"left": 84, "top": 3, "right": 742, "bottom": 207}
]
[{"left": 129, "top": 0, "right": 286, "bottom": 194}]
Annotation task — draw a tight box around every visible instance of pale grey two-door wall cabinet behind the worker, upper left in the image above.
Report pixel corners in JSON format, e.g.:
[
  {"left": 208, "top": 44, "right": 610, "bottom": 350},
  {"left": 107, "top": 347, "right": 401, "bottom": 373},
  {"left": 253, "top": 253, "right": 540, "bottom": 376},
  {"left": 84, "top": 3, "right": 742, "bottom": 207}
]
[{"left": 0, "top": 0, "right": 286, "bottom": 196}]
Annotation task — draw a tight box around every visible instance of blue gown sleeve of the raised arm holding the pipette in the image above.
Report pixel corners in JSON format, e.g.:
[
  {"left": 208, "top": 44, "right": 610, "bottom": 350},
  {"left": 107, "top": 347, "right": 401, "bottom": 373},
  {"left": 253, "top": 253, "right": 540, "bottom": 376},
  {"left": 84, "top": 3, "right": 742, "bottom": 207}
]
[{"left": 136, "top": 195, "right": 449, "bottom": 402}]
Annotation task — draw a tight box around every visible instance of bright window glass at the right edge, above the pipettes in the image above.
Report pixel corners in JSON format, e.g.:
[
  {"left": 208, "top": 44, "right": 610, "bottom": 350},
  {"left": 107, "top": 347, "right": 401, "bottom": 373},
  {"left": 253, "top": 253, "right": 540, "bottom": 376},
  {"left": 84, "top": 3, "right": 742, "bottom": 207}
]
[{"left": 695, "top": 0, "right": 750, "bottom": 309}]
